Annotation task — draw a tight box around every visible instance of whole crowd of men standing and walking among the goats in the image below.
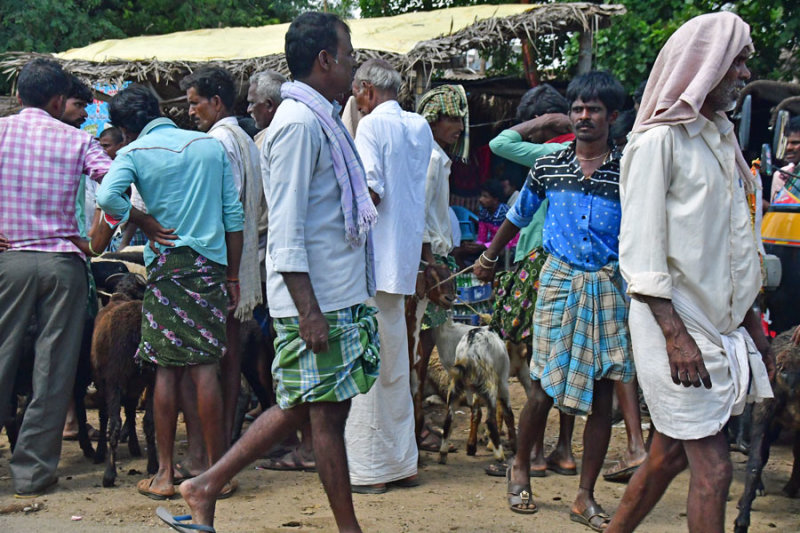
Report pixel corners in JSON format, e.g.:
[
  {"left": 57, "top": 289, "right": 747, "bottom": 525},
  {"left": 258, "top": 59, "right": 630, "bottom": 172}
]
[{"left": 0, "top": 8, "right": 784, "bottom": 532}]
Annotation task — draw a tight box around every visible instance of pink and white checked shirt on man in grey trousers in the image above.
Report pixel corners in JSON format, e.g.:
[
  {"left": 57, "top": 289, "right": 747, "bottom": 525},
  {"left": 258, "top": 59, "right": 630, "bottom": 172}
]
[{"left": 0, "top": 107, "right": 111, "bottom": 255}]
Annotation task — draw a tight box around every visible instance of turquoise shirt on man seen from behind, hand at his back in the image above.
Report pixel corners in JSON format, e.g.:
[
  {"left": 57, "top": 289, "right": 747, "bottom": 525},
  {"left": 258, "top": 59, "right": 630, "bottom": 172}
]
[{"left": 97, "top": 117, "right": 244, "bottom": 265}]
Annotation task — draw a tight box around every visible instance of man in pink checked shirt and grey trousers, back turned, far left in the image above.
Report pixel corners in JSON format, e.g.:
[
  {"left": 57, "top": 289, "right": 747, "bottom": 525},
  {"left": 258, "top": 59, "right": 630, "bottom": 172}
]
[{"left": 0, "top": 59, "right": 111, "bottom": 497}]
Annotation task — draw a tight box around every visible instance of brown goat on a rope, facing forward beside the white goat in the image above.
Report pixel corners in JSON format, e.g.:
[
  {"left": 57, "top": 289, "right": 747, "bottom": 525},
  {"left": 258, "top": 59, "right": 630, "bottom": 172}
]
[{"left": 405, "top": 264, "right": 456, "bottom": 445}]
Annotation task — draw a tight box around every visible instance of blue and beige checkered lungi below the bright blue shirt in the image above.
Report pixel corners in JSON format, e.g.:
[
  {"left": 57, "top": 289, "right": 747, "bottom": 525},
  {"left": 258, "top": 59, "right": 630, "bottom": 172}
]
[{"left": 531, "top": 255, "right": 634, "bottom": 414}]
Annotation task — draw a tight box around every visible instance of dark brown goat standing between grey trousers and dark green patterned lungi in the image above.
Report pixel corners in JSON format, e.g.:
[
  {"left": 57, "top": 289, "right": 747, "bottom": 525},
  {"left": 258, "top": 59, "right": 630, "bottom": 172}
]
[{"left": 91, "top": 274, "right": 158, "bottom": 487}]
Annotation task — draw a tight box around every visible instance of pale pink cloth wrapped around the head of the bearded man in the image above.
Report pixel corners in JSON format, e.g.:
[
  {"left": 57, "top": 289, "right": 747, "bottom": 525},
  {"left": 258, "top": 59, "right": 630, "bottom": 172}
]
[{"left": 633, "top": 11, "right": 754, "bottom": 187}]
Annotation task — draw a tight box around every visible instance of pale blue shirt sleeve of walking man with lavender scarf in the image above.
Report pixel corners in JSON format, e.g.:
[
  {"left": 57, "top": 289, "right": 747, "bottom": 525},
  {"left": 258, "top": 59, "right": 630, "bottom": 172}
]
[{"left": 264, "top": 123, "right": 310, "bottom": 272}]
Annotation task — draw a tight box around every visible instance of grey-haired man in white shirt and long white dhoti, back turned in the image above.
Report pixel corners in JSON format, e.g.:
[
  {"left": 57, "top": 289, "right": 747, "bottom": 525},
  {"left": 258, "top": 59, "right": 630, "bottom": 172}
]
[{"left": 345, "top": 59, "right": 433, "bottom": 494}]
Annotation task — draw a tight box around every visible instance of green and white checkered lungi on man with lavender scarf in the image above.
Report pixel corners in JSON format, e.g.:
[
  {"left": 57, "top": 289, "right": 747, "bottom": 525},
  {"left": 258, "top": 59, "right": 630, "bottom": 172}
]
[{"left": 272, "top": 304, "right": 380, "bottom": 409}]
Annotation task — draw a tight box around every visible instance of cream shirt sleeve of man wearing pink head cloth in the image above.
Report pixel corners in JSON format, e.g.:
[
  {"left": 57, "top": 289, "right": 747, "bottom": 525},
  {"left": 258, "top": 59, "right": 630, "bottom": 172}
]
[{"left": 619, "top": 128, "right": 673, "bottom": 299}]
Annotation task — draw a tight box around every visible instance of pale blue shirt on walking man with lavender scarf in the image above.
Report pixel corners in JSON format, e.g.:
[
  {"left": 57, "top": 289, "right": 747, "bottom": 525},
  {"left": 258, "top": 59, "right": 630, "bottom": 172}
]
[{"left": 261, "top": 82, "right": 369, "bottom": 318}]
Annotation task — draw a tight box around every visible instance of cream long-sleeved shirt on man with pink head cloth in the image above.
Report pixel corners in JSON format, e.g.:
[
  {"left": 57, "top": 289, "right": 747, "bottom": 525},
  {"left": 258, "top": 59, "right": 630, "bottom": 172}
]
[{"left": 619, "top": 116, "right": 761, "bottom": 334}]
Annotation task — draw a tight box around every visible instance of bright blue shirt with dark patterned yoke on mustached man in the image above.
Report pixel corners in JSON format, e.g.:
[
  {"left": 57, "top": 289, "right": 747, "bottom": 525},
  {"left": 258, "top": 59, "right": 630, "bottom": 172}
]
[{"left": 506, "top": 143, "right": 621, "bottom": 272}]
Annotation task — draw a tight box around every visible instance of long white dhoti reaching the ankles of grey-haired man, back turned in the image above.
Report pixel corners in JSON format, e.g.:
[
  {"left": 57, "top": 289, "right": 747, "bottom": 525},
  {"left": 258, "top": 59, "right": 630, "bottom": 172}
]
[{"left": 345, "top": 291, "right": 418, "bottom": 485}]
